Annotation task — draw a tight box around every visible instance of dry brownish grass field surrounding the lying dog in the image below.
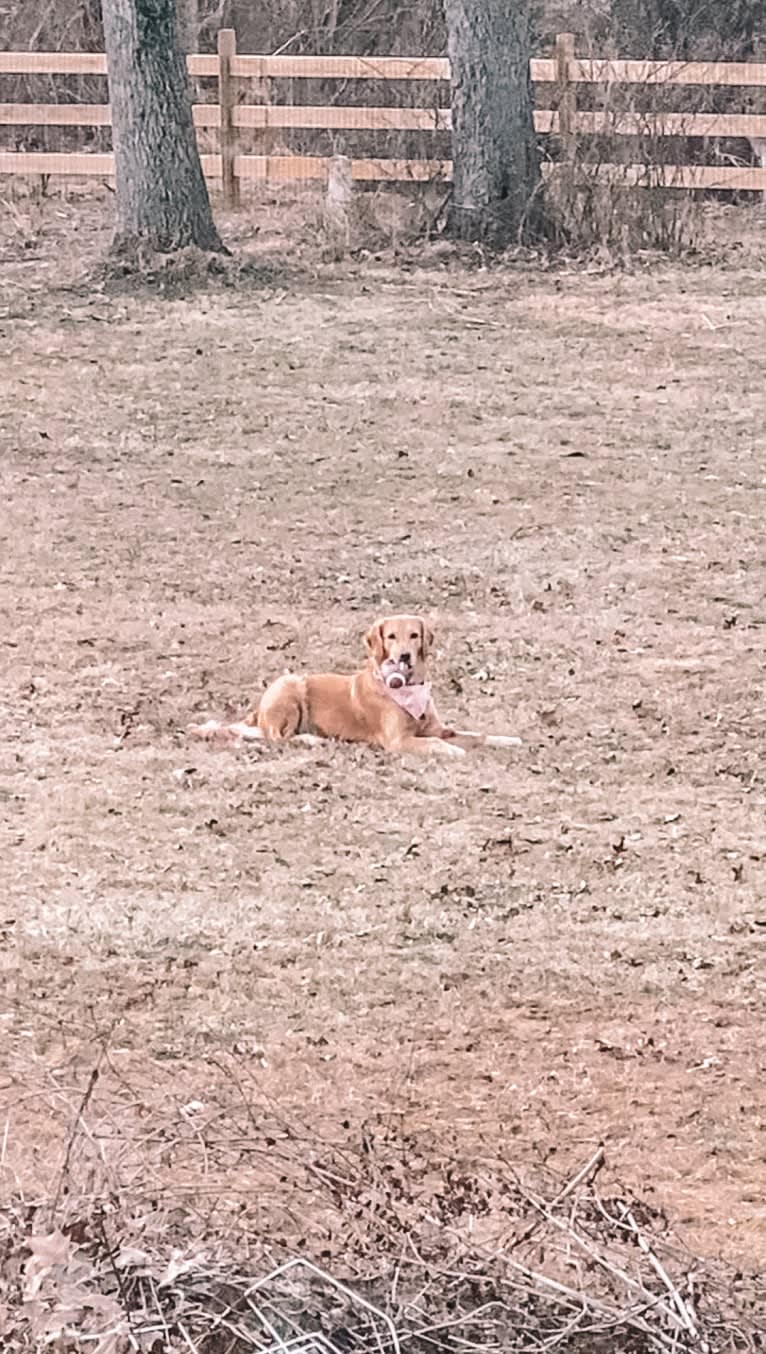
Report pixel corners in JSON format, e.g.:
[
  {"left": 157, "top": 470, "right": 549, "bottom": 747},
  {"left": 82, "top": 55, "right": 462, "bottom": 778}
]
[{"left": 0, "top": 190, "right": 766, "bottom": 1343}]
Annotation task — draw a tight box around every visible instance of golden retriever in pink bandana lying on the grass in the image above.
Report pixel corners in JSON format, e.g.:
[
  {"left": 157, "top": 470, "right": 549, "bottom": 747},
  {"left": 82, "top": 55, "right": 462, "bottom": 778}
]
[{"left": 189, "top": 616, "right": 521, "bottom": 757}]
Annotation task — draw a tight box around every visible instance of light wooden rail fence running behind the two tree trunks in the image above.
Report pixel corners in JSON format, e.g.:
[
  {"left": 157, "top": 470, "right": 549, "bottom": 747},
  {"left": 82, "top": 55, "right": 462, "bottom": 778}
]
[{"left": 0, "top": 28, "right": 766, "bottom": 204}]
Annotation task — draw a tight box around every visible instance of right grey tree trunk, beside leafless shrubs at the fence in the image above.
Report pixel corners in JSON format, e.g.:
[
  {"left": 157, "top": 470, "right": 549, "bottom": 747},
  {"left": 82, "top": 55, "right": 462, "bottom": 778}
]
[{"left": 444, "top": 0, "right": 541, "bottom": 246}]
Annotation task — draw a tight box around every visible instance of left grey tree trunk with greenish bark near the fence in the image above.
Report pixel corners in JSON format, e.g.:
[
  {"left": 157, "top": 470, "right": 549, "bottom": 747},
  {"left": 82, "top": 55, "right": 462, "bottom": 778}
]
[{"left": 103, "top": 0, "right": 223, "bottom": 255}]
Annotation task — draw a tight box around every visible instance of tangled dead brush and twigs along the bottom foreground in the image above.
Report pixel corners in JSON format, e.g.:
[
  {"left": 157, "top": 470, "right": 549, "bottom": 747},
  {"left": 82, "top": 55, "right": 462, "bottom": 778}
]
[{"left": 0, "top": 1066, "right": 766, "bottom": 1354}]
